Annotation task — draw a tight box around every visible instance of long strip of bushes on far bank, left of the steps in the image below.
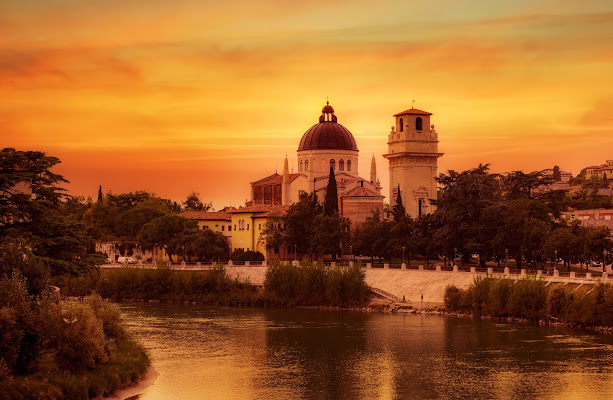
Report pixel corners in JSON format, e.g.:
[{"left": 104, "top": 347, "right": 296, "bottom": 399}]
[{"left": 54, "top": 261, "right": 370, "bottom": 307}]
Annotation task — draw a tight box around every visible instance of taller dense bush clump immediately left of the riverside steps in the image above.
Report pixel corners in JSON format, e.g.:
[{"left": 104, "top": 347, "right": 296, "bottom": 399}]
[{"left": 264, "top": 261, "right": 370, "bottom": 307}]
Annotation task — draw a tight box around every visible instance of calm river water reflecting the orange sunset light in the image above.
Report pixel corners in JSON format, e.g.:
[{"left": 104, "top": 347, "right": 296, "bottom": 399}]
[{"left": 121, "top": 304, "right": 613, "bottom": 400}]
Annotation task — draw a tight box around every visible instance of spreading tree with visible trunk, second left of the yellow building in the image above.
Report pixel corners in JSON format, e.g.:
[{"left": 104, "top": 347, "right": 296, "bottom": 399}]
[{"left": 136, "top": 214, "right": 198, "bottom": 262}]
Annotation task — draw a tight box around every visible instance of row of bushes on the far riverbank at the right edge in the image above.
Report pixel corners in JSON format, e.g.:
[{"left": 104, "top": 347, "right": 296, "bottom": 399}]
[{"left": 444, "top": 278, "right": 613, "bottom": 327}]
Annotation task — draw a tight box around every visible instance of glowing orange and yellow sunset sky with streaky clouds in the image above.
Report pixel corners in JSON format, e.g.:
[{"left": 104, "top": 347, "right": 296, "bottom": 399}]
[{"left": 0, "top": 0, "right": 613, "bottom": 208}]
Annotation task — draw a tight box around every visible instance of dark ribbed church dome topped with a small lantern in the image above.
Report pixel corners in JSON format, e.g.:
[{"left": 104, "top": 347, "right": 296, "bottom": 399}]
[{"left": 298, "top": 102, "right": 358, "bottom": 151}]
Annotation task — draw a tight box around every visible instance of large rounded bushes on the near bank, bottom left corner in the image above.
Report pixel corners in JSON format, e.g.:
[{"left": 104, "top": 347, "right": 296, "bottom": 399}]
[{"left": 0, "top": 271, "right": 149, "bottom": 400}]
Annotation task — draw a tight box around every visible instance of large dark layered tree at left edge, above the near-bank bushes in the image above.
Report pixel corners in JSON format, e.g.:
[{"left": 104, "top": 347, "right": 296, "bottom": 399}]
[{"left": 0, "top": 148, "right": 102, "bottom": 274}]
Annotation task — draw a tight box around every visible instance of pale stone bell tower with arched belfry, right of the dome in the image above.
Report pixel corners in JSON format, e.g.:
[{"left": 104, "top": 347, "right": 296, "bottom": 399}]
[{"left": 383, "top": 108, "right": 443, "bottom": 218}]
